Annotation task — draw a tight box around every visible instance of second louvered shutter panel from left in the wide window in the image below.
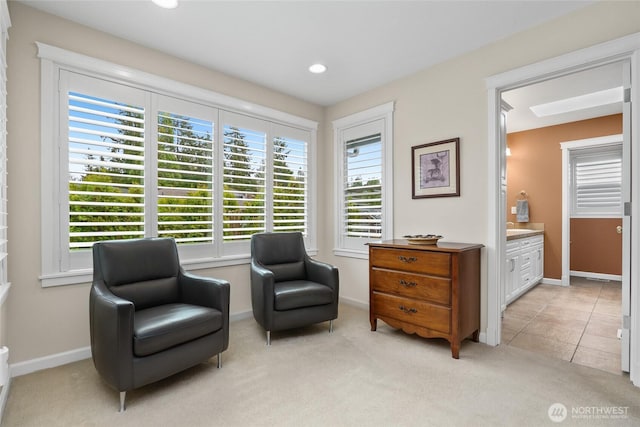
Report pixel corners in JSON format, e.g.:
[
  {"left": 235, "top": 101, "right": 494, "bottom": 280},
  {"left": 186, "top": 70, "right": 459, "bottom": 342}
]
[{"left": 157, "top": 111, "right": 214, "bottom": 243}]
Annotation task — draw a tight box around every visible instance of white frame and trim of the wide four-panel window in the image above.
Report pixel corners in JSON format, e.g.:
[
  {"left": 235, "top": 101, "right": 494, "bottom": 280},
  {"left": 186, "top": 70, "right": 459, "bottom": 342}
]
[{"left": 36, "top": 42, "right": 318, "bottom": 287}]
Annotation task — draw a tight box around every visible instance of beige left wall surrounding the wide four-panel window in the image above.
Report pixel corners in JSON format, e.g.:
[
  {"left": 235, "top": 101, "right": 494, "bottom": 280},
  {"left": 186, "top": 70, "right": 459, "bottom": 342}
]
[{"left": 5, "top": 2, "right": 325, "bottom": 363}]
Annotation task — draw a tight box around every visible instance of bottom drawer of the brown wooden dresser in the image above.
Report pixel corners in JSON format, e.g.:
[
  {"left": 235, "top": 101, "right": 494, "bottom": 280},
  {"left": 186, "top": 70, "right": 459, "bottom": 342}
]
[{"left": 373, "top": 292, "right": 451, "bottom": 334}]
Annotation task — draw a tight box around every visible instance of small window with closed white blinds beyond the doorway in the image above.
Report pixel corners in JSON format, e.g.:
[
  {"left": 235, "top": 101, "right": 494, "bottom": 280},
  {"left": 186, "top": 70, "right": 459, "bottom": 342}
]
[{"left": 571, "top": 144, "right": 622, "bottom": 217}]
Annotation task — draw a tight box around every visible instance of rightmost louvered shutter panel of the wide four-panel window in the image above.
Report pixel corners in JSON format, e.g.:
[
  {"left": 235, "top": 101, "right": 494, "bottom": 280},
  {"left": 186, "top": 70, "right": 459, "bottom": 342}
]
[{"left": 271, "top": 131, "right": 309, "bottom": 236}]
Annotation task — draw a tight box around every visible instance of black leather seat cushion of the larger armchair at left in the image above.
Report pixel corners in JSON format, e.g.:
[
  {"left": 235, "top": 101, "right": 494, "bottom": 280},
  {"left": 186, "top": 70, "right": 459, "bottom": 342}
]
[{"left": 133, "top": 303, "right": 222, "bottom": 357}]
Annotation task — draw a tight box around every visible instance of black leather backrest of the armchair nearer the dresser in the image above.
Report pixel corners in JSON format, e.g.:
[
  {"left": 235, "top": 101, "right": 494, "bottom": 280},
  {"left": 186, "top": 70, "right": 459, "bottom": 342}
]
[{"left": 251, "top": 232, "right": 307, "bottom": 282}]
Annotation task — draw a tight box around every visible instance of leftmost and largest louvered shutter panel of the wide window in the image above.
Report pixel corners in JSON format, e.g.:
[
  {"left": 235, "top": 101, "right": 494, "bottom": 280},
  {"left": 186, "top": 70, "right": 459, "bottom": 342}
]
[{"left": 68, "top": 92, "right": 145, "bottom": 249}]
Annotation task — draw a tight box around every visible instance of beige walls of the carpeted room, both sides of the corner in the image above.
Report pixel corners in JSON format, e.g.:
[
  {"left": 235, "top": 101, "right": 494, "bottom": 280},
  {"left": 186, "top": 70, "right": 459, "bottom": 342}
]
[{"left": 7, "top": 2, "right": 640, "bottom": 363}]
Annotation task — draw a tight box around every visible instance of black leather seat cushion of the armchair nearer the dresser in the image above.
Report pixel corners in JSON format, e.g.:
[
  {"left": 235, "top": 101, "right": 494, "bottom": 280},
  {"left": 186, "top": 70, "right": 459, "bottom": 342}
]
[{"left": 274, "top": 280, "right": 335, "bottom": 311}]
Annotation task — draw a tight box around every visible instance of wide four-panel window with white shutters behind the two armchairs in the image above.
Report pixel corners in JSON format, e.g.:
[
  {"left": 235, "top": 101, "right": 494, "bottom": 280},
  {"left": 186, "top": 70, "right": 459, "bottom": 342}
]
[{"left": 40, "top": 56, "right": 315, "bottom": 286}]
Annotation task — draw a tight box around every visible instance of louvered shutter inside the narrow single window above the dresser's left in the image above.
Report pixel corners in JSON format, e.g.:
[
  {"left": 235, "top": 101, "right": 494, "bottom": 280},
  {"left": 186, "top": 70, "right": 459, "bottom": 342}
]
[{"left": 343, "top": 133, "right": 382, "bottom": 239}]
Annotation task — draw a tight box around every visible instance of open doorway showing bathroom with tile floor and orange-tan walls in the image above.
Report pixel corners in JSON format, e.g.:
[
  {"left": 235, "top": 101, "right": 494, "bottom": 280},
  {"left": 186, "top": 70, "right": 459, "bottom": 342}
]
[{"left": 501, "top": 62, "right": 628, "bottom": 374}]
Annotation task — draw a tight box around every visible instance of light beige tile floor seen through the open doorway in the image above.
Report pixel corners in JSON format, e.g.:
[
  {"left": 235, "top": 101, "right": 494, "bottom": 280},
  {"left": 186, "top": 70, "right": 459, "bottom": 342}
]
[{"left": 502, "top": 277, "right": 622, "bottom": 375}]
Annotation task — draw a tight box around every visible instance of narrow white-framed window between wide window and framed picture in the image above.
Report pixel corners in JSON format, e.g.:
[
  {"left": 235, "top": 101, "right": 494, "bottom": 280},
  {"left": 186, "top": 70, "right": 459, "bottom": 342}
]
[{"left": 333, "top": 103, "right": 393, "bottom": 258}]
